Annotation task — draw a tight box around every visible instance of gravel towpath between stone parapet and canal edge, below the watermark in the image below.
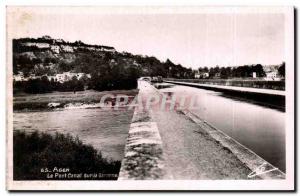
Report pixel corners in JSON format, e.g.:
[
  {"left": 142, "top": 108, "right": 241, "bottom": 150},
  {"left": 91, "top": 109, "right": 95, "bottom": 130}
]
[{"left": 153, "top": 110, "right": 251, "bottom": 180}]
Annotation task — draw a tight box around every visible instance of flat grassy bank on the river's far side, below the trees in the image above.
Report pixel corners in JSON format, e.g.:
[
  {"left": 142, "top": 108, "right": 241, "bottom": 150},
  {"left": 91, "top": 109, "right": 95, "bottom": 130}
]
[{"left": 13, "top": 90, "right": 138, "bottom": 111}]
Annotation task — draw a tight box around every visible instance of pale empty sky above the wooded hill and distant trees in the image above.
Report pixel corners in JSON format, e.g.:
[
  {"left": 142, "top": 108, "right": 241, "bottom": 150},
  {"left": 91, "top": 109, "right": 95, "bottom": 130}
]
[{"left": 8, "top": 8, "right": 285, "bottom": 69}]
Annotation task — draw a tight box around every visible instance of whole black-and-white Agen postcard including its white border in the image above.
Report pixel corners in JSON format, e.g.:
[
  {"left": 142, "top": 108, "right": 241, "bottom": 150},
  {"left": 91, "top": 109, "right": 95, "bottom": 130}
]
[{"left": 6, "top": 6, "right": 295, "bottom": 191}]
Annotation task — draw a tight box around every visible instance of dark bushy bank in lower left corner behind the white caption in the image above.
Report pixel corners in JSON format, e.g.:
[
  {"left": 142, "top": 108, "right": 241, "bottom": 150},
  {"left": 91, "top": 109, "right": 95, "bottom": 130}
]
[{"left": 13, "top": 131, "right": 121, "bottom": 180}]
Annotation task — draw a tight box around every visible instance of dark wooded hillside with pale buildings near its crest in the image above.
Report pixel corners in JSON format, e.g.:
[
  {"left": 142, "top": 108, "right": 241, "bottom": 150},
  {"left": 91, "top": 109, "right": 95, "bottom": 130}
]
[{"left": 13, "top": 36, "right": 192, "bottom": 93}]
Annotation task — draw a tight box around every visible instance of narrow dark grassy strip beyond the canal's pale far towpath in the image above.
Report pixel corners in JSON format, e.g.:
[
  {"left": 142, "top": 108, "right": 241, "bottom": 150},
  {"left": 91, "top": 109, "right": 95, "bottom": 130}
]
[{"left": 165, "top": 78, "right": 285, "bottom": 90}]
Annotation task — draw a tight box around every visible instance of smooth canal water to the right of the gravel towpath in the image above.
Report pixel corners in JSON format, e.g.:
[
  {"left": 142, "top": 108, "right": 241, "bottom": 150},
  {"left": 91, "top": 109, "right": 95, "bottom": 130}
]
[{"left": 160, "top": 85, "right": 285, "bottom": 171}]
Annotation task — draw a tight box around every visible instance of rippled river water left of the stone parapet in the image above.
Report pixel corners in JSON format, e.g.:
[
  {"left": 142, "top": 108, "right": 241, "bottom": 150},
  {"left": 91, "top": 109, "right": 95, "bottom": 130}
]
[{"left": 13, "top": 108, "right": 133, "bottom": 160}]
